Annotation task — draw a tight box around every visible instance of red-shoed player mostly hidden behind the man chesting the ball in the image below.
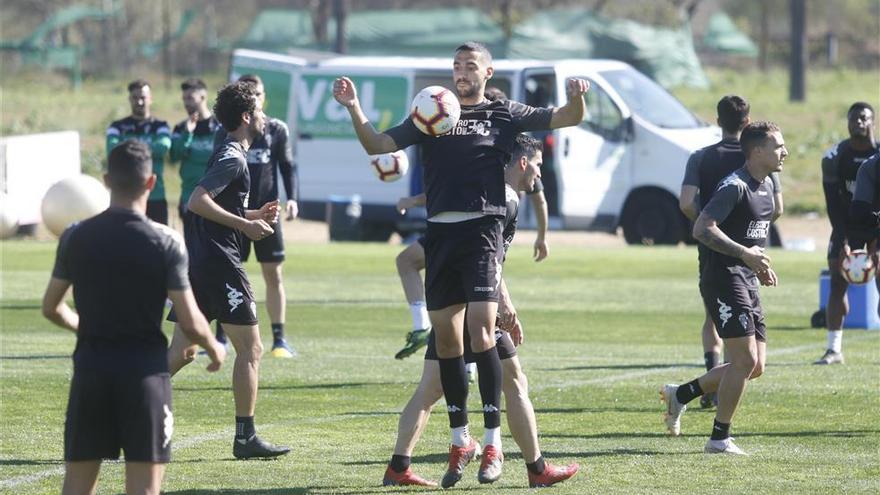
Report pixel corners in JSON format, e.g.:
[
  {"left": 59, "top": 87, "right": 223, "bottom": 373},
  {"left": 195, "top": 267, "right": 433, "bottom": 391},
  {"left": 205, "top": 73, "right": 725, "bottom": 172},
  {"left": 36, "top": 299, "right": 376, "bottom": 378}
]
[{"left": 383, "top": 134, "right": 579, "bottom": 487}]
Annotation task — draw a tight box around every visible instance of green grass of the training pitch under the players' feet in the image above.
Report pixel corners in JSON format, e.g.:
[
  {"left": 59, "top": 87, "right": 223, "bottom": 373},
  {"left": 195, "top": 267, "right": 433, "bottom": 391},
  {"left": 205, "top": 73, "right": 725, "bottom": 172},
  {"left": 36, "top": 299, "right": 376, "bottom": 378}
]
[{"left": 0, "top": 241, "right": 880, "bottom": 494}]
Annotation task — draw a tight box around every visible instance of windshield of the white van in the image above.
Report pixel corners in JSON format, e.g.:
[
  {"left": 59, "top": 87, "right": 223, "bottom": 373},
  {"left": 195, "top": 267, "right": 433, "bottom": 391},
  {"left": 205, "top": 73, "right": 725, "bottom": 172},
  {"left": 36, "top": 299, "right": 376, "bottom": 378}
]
[{"left": 601, "top": 69, "right": 703, "bottom": 129}]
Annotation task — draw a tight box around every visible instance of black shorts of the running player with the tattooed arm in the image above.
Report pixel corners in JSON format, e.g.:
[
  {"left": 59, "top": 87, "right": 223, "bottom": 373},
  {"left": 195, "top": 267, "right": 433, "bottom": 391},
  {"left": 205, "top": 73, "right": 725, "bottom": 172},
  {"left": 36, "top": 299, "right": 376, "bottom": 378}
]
[{"left": 700, "top": 271, "right": 767, "bottom": 342}]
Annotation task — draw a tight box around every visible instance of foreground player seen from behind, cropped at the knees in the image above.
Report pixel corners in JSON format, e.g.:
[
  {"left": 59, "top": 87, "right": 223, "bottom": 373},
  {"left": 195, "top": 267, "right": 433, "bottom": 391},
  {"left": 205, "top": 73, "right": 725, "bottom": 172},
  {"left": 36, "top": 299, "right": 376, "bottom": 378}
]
[{"left": 43, "top": 140, "right": 226, "bottom": 495}]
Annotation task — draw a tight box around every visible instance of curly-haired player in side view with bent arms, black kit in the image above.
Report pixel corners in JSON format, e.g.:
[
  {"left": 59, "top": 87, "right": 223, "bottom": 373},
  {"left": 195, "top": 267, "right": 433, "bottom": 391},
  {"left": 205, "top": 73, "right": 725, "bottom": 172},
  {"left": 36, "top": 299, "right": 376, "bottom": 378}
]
[{"left": 168, "top": 82, "right": 290, "bottom": 459}]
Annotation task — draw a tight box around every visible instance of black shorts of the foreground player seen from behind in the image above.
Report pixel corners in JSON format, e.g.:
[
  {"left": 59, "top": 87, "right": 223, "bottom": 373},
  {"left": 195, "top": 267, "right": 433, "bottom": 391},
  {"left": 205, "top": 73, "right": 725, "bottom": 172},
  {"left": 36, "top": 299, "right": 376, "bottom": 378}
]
[{"left": 64, "top": 370, "right": 174, "bottom": 463}]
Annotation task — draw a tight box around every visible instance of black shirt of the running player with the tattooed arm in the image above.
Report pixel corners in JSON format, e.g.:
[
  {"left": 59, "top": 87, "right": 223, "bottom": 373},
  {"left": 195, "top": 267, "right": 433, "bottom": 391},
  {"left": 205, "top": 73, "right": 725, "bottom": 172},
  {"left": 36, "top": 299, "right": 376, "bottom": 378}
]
[{"left": 703, "top": 167, "right": 775, "bottom": 276}]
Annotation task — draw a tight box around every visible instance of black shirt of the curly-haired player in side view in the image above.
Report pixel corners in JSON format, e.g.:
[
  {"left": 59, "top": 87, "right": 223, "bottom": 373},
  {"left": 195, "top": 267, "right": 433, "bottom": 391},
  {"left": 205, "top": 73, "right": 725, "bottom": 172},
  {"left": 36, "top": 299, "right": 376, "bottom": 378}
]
[{"left": 187, "top": 140, "right": 251, "bottom": 266}]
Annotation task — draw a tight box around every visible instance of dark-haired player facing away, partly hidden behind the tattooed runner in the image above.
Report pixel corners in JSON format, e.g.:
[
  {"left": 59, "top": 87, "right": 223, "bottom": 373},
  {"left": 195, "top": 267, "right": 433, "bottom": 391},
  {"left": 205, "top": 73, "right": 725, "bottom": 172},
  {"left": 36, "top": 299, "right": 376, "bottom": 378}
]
[{"left": 679, "top": 95, "right": 783, "bottom": 408}]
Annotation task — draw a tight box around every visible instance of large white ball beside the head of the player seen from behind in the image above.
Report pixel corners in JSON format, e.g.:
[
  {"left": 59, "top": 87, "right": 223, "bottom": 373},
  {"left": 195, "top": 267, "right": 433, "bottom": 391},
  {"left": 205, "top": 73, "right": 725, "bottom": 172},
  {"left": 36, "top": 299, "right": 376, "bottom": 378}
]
[{"left": 40, "top": 175, "right": 110, "bottom": 237}]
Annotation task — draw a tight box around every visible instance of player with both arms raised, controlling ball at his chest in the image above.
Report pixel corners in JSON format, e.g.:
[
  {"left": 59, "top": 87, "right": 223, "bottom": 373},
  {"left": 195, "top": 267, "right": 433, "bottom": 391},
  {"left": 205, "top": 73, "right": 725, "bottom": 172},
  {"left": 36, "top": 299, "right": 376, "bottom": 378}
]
[{"left": 333, "top": 42, "right": 589, "bottom": 488}]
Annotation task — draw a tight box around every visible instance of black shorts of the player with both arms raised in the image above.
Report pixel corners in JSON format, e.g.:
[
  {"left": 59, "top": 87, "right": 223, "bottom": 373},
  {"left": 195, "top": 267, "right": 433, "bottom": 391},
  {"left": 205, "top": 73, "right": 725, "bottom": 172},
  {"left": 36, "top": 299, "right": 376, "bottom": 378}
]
[{"left": 424, "top": 216, "right": 504, "bottom": 311}]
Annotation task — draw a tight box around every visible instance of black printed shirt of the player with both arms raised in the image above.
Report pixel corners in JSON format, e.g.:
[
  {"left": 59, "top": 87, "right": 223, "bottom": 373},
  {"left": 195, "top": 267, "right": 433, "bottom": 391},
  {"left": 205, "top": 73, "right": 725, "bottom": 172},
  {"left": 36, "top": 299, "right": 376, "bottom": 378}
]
[{"left": 385, "top": 100, "right": 553, "bottom": 218}]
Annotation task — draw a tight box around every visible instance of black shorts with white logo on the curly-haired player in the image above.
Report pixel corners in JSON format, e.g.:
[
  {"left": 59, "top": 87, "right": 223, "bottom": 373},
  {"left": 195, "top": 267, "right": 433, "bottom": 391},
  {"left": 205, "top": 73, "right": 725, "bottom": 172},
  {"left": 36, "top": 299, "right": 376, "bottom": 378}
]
[{"left": 168, "top": 262, "right": 257, "bottom": 325}]
